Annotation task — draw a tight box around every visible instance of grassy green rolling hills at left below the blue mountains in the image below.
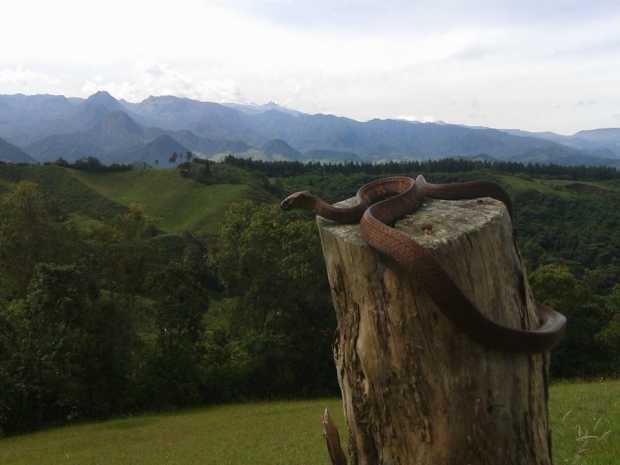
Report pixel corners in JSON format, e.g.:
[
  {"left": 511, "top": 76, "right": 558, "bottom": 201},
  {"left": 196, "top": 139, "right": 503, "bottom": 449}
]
[{"left": 0, "top": 165, "right": 271, "bottom": 233}]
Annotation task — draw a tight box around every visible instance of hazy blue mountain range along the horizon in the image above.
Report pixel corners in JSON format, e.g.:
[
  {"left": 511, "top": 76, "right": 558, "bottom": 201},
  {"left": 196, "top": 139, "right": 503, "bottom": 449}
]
[{"left": 0, "top": 91, "right": 620, "bottom": 167}]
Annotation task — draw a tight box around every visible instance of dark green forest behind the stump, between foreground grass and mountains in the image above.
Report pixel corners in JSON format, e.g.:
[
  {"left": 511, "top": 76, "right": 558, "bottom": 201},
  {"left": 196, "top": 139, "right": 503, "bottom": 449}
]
[{"left": 0, "top": 157, "right": 620, "bottom": 435}]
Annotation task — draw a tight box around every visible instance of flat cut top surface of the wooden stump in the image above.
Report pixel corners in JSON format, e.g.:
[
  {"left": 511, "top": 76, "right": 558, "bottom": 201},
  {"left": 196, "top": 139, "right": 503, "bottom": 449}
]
[{"left": 317, "top": 197, "right": 508, "bottom": 249}]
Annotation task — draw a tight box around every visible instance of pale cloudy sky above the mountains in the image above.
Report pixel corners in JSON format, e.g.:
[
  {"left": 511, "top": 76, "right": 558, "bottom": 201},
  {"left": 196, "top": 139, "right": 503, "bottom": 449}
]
[{"left": 0, "top": 0, "right": 620, "bottom": 133}]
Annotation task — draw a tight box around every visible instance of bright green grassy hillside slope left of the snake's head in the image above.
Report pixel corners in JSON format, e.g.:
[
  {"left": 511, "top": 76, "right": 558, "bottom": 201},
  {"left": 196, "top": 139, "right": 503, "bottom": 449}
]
[{"left": 70, "top": 170, "right": 249, "bottom": 232}]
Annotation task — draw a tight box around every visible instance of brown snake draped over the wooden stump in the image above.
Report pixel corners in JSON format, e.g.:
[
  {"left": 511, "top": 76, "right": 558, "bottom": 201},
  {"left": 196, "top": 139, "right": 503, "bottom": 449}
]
[{"left": 280, "top": 175, "right": 566, "bottom": 353}]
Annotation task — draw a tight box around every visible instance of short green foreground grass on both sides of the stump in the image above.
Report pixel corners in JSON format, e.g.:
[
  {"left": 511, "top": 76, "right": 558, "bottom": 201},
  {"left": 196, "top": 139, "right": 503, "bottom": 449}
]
[{"left": 0, "top": 381, "right": 620, "bottom": 465}]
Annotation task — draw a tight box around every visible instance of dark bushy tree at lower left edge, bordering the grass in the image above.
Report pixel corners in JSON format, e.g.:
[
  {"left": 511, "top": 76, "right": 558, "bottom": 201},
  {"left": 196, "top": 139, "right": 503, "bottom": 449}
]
[{"left": 0, "top": 263, "right": 134, "bottom": 432}]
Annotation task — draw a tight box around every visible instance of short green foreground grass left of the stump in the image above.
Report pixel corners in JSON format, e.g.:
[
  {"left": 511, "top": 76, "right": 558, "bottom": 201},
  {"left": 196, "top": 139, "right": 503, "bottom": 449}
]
[{"left": 0, "top": 399, "right": 342, "bottom": 465}]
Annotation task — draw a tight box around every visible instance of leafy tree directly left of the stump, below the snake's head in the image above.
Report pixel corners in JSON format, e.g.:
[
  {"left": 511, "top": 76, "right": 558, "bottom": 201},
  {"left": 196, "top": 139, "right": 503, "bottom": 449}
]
[{"left": 213, "top": 202, "right": 335, "bottom": 394}]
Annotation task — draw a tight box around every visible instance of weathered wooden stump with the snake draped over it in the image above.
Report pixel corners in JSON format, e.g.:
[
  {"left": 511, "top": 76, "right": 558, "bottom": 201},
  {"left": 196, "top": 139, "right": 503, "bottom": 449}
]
[{"left": 318, "top": 199, "right": 551, "bottom": 465}]
